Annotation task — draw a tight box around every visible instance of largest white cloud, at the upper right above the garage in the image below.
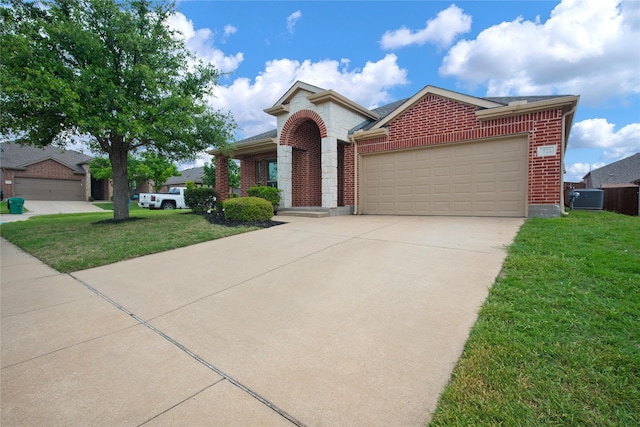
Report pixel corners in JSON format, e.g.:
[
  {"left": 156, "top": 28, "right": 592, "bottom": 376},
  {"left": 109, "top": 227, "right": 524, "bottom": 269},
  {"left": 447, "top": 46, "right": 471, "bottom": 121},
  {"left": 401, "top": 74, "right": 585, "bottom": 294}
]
[{"left": 440, "top": 0, "right": 640, "bottom": 104}]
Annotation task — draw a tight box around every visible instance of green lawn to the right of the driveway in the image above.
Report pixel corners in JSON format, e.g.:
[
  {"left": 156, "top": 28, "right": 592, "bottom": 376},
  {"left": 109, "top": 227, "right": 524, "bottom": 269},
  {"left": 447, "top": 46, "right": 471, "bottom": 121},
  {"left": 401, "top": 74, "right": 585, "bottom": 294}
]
[{"left": 430, "top": 211, "right": 640, "bottom": 426}]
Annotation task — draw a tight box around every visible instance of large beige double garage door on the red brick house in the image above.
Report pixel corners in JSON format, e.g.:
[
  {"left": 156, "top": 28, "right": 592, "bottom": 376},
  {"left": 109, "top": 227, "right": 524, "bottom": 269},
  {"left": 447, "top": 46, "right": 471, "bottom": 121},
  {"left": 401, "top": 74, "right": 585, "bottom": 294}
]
[{"left": 360, "top": 137, "right": 528, "bottom": 217}]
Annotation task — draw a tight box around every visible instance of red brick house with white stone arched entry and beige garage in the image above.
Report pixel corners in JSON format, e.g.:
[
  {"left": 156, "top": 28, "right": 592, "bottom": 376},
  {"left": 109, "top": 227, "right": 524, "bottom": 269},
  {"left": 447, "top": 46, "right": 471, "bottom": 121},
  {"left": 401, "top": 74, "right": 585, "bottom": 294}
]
[{"left": 210, "top": 82, "right": 579, "bottom": 217}]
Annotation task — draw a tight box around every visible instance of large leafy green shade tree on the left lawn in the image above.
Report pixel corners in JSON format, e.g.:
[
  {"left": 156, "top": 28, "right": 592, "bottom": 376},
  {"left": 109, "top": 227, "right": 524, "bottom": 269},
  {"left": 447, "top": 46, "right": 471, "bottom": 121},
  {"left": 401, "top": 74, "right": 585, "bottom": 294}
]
[{"left": 0, "top": 0, "right": 235, "bottom": 219}]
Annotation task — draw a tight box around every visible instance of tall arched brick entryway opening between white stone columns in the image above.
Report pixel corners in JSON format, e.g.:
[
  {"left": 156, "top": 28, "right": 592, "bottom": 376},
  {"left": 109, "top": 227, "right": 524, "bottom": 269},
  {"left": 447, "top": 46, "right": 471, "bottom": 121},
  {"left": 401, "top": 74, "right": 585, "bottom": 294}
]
[{"left": 287, "top": 119, "right": 322, "bottom": 207}]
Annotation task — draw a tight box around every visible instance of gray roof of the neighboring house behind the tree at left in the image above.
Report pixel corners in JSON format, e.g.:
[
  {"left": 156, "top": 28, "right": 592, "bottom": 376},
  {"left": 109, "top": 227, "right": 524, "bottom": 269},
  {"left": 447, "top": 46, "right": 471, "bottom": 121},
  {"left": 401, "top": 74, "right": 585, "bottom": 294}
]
[{"left": 0, "top": 142, "right": 93, "bottom": 173}]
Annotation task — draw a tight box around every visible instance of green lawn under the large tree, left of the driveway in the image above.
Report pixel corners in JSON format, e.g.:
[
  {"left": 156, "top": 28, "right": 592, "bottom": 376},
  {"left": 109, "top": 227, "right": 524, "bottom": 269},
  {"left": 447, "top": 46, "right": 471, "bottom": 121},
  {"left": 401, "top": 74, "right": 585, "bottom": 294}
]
[{"left": 0, "top": 209, "right": 255, "bottom": 273}]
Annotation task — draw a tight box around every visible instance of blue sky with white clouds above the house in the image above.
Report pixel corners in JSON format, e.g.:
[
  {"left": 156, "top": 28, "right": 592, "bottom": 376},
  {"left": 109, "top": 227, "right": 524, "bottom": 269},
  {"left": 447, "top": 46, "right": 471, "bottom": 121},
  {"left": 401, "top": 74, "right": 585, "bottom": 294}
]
[{"left": 171, "top": 0, "right": 640, "bottom": 181}]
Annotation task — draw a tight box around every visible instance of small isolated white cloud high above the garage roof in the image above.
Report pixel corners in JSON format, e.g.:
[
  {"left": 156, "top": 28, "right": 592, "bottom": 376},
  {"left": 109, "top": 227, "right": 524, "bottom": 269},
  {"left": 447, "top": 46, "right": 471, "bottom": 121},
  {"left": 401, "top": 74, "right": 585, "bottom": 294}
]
[{"left": 380, "top": 4, "right": 471, "bottom": 50}]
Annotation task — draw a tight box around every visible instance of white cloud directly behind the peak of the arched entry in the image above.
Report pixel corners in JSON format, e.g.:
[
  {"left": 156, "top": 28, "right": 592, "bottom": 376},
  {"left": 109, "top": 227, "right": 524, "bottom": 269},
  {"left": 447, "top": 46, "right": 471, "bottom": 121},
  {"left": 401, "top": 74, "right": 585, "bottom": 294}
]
[{"left": 210, "top": 54, "right": 408, "bottom": 137}]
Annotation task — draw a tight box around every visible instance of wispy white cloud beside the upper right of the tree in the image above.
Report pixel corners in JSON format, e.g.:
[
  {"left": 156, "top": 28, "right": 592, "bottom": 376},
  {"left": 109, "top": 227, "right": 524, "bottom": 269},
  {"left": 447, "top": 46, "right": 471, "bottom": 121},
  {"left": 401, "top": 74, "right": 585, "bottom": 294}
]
[{"left": 168, "top": 12, "right": 244, "bottom": 73}]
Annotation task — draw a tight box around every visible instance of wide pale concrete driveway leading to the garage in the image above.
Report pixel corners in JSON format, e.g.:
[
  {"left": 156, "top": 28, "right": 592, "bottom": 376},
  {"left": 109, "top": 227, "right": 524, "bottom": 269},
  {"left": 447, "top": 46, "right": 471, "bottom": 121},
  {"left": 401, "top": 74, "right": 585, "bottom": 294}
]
[{"left": 1, "top": 216, "right": 523, "bottom": 426}]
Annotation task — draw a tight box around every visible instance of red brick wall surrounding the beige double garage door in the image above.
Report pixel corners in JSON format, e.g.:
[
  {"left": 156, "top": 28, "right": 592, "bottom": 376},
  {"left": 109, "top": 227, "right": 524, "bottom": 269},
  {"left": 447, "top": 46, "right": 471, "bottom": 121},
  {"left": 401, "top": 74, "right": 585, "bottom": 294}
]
[{"left": 356, "top": 95, "right": 562, "bottom": 204}]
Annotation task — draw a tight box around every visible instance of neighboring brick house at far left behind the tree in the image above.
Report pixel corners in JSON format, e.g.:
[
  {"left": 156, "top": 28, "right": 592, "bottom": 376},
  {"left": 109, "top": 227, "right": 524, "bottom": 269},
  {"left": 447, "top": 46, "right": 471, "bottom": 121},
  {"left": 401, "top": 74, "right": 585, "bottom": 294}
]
[{"left": 0, "top": 142, "right": 93, "bottom": 200}]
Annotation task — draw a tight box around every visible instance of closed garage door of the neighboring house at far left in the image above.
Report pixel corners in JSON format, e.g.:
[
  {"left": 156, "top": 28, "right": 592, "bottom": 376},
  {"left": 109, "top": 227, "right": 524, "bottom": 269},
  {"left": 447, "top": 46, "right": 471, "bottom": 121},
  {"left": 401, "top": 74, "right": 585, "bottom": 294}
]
[{"left": 14, "top": 177, "right": 85, "bottom": 200}]
